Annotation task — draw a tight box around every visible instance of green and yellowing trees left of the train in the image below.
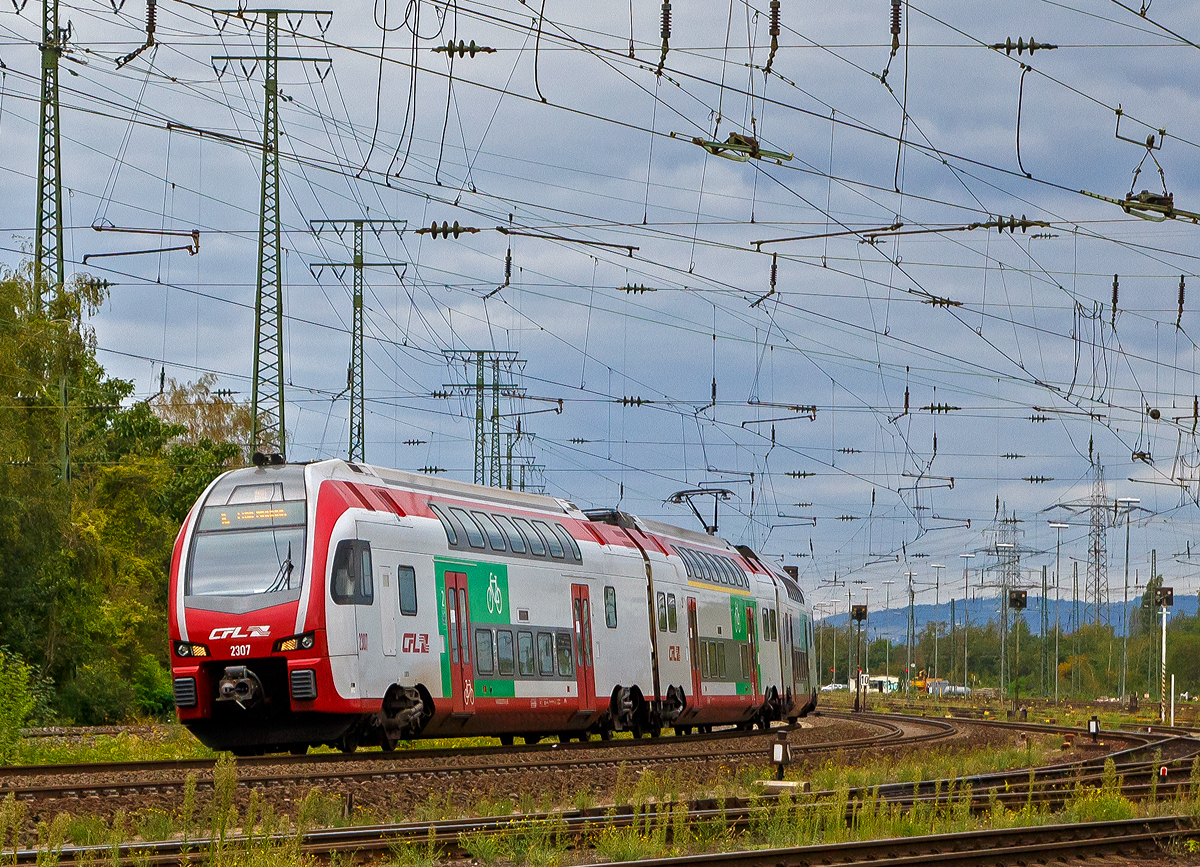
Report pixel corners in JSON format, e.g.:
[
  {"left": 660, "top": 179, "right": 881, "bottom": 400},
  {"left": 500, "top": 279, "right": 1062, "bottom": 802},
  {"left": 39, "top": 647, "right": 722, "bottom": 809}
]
[{"left": 0, "top": 269, "right": 247, "bottom": 720}]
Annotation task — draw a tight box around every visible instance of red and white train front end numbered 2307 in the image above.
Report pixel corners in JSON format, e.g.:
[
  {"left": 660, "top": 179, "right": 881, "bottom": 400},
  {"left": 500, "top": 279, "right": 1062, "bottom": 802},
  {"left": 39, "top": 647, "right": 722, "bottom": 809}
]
[{"left": 169, "top": 466, "right": 343, "bottom": 754}]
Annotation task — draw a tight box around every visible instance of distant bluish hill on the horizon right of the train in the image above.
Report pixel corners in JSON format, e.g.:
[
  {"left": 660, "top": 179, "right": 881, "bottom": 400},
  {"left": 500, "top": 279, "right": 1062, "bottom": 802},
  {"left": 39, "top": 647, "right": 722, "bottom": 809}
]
[{"left": 816, "top": 588, "right": 1200, "bottom": 641}]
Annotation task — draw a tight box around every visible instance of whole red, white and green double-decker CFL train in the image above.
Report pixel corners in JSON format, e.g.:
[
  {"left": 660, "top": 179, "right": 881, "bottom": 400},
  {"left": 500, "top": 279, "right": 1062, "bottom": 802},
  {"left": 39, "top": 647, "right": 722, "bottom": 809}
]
[{"left": 169, "top": 460, "right": 817, "bottom": 754}]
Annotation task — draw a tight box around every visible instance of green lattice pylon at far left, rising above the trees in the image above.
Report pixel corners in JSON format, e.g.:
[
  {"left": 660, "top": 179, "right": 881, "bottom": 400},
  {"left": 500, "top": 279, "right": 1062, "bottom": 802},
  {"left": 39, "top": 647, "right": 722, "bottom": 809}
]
[{"left": 34, "top": 0, "right": 71, "bottom": 312}]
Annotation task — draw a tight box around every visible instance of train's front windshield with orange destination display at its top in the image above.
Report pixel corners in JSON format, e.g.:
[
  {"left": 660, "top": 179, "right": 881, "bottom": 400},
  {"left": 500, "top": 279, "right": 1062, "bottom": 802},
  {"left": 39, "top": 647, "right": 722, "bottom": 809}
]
[{"left": 186, "top": 500, "right": 305, "bottom": 596}]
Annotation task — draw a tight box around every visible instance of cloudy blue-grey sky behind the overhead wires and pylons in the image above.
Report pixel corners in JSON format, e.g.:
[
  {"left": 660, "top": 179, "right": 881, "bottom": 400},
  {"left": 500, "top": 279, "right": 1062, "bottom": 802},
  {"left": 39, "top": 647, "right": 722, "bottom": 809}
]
[{"left": 0, "top": 0, "right": 1200, "bottom": 612}]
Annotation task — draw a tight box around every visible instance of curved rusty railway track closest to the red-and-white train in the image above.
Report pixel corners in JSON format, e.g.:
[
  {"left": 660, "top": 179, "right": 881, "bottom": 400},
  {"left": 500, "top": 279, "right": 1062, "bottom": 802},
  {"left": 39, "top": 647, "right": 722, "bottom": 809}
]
[{"left": 0, "top": 718, "right": 956, "bottom": 801}]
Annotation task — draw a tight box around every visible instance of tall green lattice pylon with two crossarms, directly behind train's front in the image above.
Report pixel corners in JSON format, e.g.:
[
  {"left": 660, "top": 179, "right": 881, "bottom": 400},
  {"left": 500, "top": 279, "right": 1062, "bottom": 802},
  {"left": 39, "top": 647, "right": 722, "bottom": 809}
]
[{"left": 212, "top": 8, "right": 334, "bottom": 456}]
